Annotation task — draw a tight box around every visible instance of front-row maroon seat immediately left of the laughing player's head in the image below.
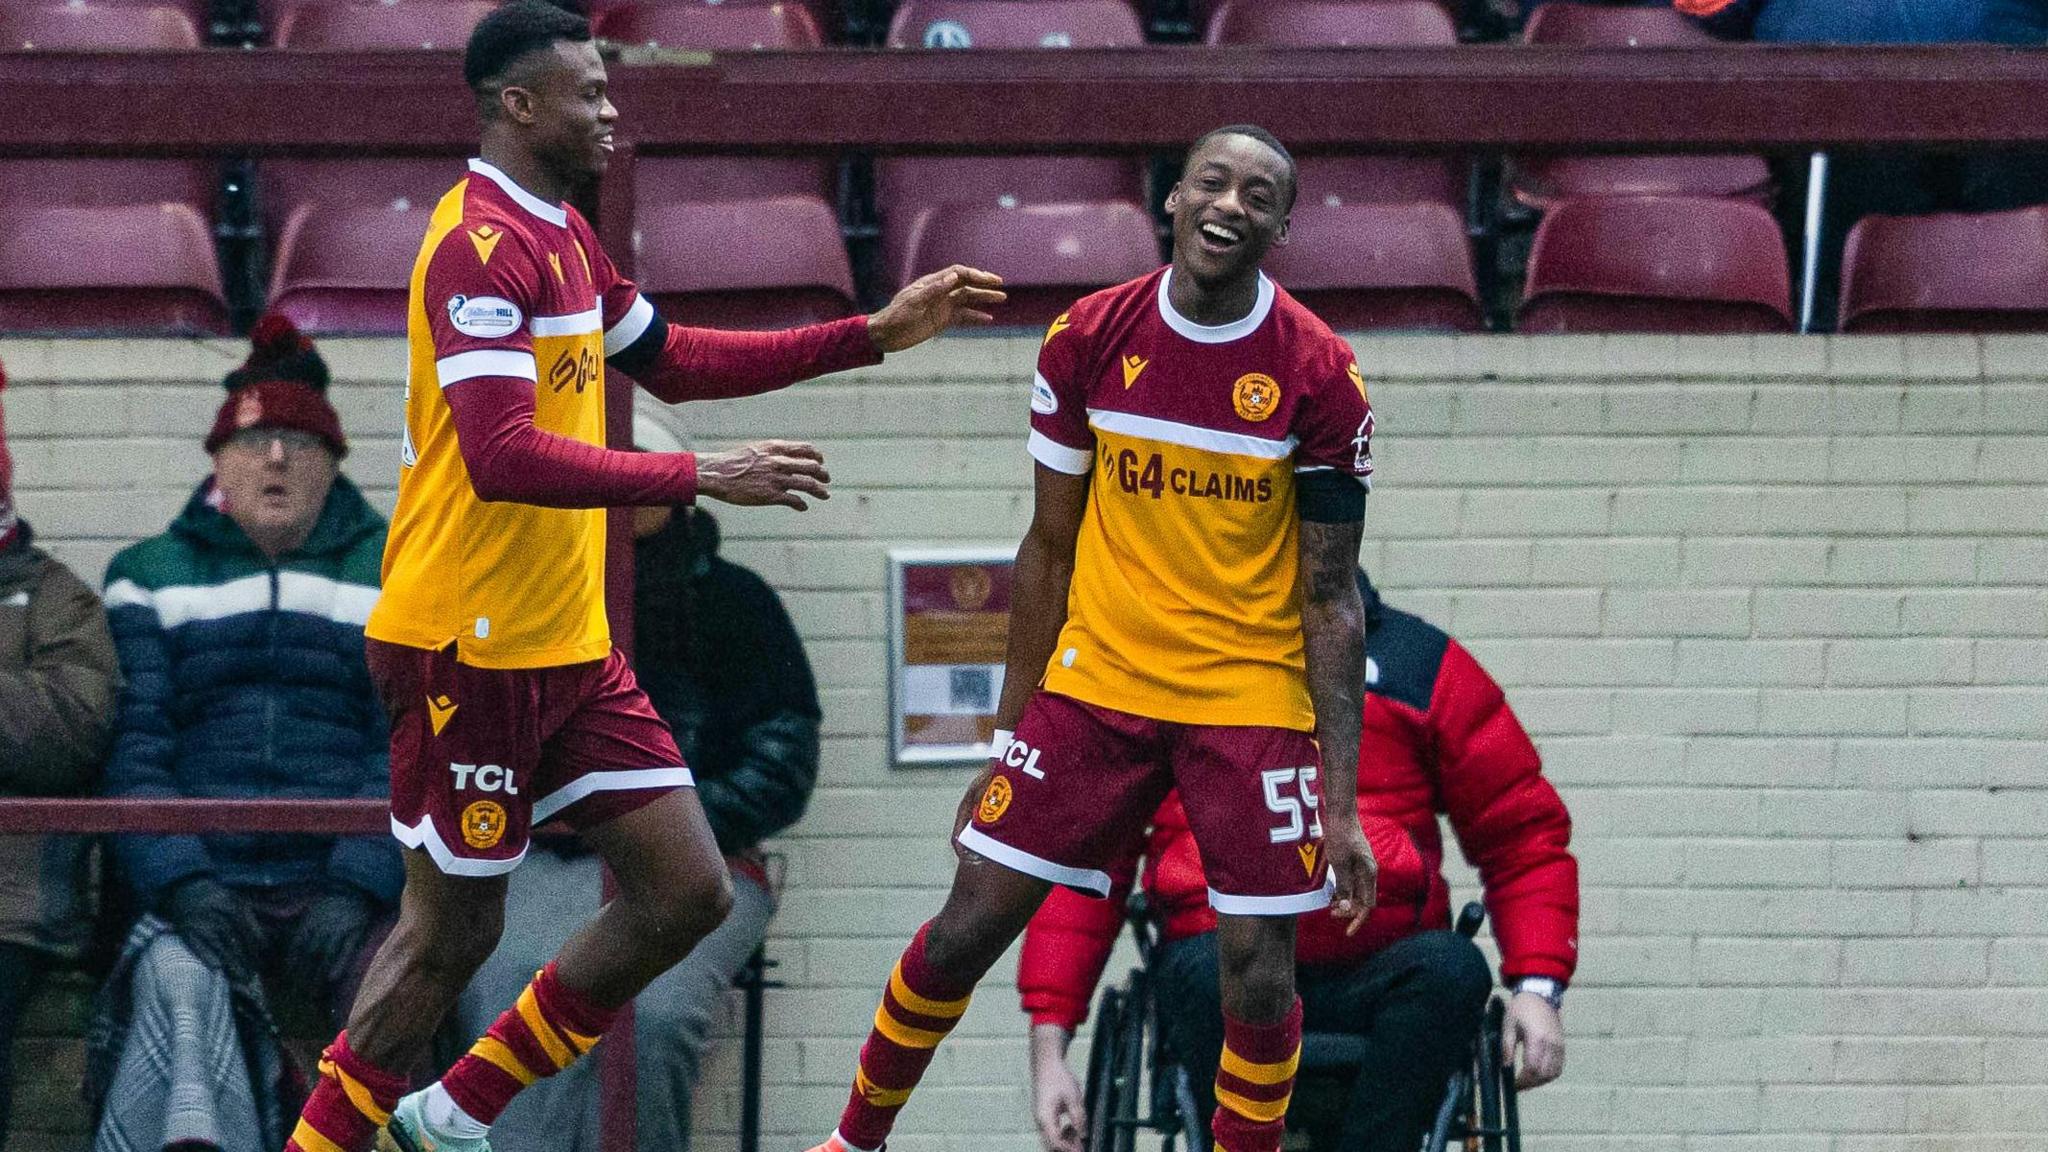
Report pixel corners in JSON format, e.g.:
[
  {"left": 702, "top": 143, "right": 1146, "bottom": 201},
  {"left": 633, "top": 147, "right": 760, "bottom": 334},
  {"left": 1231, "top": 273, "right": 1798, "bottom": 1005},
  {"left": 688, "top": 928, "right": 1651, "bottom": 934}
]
[{"left": 907, "top": 201, "right": 1159, "bottom": 326}]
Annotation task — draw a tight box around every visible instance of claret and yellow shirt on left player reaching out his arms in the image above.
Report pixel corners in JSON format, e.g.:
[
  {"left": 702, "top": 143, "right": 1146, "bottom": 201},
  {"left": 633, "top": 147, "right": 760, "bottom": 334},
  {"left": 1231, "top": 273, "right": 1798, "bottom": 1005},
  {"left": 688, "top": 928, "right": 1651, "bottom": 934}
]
[{"left": 365, "top": 160, "right": 653, "bottom": 668}]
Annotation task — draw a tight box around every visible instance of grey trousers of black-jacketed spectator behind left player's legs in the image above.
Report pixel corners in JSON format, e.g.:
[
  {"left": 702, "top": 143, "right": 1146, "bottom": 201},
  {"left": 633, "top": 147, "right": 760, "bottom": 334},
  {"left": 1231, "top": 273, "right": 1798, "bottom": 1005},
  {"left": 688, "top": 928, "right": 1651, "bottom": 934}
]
[{"left": 455, "top": 849, "right": 774, "bottom": 1152}]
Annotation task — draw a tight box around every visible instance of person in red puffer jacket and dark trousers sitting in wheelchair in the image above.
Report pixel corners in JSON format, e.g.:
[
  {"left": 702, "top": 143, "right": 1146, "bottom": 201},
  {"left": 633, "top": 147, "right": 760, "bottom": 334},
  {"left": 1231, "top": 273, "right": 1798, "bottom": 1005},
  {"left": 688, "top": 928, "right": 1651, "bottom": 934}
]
[{"left": 1018, "top": 572, "right": 1579, "bottom": 1152}]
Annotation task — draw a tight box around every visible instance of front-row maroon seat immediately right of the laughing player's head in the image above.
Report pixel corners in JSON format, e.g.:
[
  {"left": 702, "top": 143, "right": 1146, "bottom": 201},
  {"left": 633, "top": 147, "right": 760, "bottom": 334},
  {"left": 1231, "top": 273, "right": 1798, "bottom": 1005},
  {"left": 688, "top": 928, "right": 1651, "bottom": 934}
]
[{"left": 1266, "top": 203, "right": 1483, "bottom": 332}]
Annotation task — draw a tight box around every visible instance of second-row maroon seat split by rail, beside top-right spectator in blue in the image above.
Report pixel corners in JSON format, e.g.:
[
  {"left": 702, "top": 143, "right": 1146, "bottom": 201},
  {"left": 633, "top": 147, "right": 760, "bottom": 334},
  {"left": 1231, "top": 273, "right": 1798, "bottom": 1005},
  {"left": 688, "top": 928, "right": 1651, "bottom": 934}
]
[{"left": 1511, "top": 4, "right": 1772, "bottom": 209}]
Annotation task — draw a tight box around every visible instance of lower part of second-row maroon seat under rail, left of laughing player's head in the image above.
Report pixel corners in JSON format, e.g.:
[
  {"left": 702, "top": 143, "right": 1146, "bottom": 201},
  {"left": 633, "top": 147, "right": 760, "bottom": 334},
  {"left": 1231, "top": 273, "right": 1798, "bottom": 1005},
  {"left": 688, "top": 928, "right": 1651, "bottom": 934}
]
[{"left": 874, "top": 156, "right": 1145, "bottom": 287}]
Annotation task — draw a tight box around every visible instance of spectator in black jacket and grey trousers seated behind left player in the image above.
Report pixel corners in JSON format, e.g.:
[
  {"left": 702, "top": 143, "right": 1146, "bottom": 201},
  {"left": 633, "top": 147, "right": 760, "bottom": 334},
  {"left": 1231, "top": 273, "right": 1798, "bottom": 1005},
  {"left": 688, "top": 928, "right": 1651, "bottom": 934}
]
[{"left": 455, "top": 418, "right": 821, "bottom": 1152}]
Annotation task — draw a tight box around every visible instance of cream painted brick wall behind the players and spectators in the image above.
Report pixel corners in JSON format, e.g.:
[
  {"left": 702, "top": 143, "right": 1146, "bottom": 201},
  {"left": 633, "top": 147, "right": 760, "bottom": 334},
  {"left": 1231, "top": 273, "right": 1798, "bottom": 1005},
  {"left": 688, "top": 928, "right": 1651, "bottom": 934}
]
[{"left": 0, "top": 336, "right": 2048, "bottom": 1152}]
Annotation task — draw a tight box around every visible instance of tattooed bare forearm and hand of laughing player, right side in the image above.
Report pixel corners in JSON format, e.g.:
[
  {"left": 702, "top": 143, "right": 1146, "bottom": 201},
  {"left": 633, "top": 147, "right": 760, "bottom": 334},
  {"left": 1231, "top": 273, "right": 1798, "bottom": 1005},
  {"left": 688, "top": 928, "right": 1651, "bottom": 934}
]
[{"left": 1300, "top": 519, "right": 1378, "bottom": 933}]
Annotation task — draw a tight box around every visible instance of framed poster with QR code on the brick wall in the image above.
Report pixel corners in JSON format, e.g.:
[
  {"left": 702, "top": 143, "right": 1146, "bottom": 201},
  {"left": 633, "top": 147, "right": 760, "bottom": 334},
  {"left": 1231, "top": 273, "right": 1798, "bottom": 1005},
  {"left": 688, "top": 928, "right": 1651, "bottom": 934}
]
[{"left": 889, "top": 545, "right": 1016, "bottom": 765}]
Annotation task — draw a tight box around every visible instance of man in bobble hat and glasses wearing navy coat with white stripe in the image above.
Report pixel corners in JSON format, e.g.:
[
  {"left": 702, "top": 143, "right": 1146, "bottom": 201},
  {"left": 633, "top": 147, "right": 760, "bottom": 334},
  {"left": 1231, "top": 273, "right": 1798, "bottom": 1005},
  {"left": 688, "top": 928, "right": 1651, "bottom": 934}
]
[{"left": 88, "top": 318, "right": 399, "bottom": 1152}]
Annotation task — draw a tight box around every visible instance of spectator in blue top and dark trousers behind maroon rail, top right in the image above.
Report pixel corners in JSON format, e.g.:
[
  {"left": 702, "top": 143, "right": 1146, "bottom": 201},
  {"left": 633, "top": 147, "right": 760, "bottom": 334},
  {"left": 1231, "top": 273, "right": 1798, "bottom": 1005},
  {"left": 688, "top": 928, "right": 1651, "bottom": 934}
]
[{"left": 1673, "top": 0, "right": 2048, "bottom": 326}]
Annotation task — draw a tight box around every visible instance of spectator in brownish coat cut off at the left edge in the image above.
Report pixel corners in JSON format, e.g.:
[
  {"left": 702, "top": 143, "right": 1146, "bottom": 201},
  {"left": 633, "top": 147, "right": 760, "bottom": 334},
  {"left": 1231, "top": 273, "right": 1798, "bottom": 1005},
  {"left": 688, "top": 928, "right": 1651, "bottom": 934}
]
[{"left": 0, "top": 358, "right": 119, "bottom": 1148}]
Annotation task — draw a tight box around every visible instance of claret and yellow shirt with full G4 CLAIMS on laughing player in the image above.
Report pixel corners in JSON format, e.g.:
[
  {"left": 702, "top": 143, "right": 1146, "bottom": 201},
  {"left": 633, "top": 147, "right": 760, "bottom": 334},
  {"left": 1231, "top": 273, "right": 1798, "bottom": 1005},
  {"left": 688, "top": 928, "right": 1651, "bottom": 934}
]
[{"left": 1030, "top": 269, "right": 1372, "bottom": 732}]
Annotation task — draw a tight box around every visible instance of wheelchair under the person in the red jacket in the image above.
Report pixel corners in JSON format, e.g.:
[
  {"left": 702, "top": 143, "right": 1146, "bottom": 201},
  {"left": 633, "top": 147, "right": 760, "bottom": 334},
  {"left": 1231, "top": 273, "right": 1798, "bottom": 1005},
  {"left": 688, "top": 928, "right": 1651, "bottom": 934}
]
[{"left": 1083, "top": 892, "right": 1522, "bottom": 1152}]
